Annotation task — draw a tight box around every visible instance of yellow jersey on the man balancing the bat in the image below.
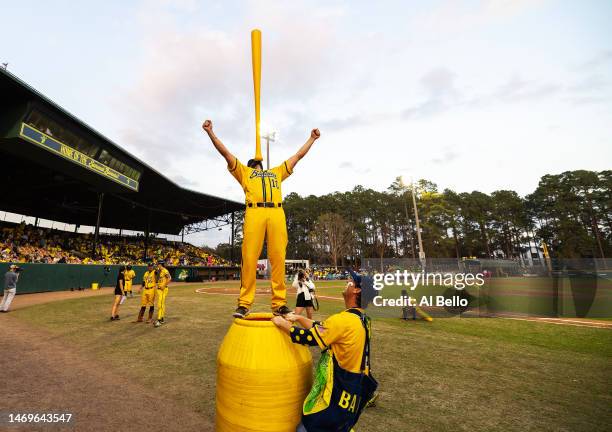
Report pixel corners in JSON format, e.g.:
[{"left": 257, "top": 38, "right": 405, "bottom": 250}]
[{"left": 227, "top": 158, "right": 293, "bottom": 205}]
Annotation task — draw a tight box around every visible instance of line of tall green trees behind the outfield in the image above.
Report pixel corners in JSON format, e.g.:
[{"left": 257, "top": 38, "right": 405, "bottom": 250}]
[{"left": 216, "top": 170, "right": 612, "bottom": 266}]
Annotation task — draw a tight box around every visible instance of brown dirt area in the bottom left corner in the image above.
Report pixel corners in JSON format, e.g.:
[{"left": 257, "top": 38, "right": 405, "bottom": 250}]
[{"left": 0, "top": 315, "right": 214, "bottom": 432}]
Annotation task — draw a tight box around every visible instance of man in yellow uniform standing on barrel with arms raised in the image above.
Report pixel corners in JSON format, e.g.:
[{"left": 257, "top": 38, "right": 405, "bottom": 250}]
[{"left": 202, "top": 120, "right": 321, "bottom": 318}]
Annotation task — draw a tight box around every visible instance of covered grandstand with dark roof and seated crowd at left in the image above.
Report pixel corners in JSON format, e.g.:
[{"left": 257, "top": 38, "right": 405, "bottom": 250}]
[{"left": 0, "top": 69, "right": 244, "bottom": 290}]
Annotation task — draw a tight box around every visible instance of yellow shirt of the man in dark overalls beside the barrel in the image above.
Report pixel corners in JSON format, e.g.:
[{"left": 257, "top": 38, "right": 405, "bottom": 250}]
[{"left": 310, "top": 311, "right": 365, "bottom": 373}]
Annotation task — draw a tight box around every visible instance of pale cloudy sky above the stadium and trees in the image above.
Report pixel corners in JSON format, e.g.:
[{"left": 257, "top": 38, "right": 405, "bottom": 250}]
[{"left": 0, "top": 0, "right": 612, "bottom": 246}]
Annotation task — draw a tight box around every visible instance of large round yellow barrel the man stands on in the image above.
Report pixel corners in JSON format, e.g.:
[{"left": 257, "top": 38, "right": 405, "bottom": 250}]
[{"left": 216, "top": 313, "right": 312, "bottom": 432}]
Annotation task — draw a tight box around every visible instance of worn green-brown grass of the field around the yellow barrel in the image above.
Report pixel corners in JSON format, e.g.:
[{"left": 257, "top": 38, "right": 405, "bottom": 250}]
[{"left": 12, "top": 282, "right": 612, "bottom": 432}]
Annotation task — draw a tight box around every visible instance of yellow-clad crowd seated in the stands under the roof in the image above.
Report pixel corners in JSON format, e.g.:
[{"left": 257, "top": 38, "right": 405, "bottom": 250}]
[{"left": 0, "top": 222, "right": 230, "bottom": 266}]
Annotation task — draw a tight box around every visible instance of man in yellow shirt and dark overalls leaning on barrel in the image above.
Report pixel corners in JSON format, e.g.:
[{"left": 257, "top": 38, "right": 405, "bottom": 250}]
[{"left": 272, "top": 272, "right": 378, "bottom": 432}]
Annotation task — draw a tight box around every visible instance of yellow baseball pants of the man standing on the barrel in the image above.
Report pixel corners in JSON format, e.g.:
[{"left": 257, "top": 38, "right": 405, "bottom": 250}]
[{"left": 238, "top": 207, "right": 287, "bottom": 309}]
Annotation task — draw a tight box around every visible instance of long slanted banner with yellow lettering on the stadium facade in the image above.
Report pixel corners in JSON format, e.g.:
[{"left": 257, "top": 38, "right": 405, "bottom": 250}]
[{"left": 19, "top": 123, "right": 139, "bottom": 191}]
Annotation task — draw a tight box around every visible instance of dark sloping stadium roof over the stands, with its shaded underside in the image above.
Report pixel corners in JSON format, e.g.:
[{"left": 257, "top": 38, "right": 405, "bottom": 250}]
[{"left": 0, "top": 68, "right": 244, "bottom": 234}]
